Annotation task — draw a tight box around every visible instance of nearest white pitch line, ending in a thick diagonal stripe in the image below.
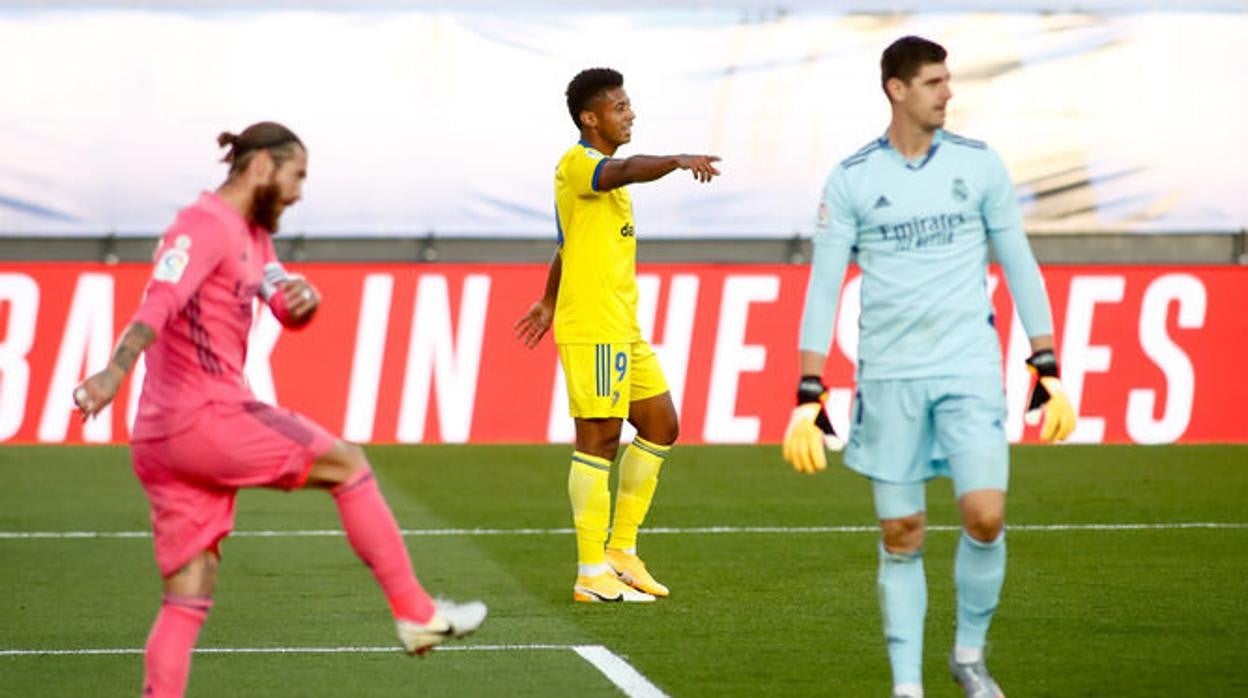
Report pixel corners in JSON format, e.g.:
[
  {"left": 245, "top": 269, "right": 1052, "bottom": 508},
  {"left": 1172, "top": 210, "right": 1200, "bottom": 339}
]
[{"left": 0, "top": 644, "right": 668, "bottom": 698}]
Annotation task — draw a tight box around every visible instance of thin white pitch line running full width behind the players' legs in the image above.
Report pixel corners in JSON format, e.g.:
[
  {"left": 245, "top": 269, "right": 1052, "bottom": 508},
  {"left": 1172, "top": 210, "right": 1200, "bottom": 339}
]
[{"left": 0, "top": 521, "right": 1248, "bottom": 541}]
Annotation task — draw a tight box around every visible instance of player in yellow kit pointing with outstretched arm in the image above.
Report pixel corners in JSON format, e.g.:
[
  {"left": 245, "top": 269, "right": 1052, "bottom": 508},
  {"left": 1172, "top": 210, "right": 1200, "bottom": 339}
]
[{"left": 515, "top": 67, "right": 719, "bottom": 602}]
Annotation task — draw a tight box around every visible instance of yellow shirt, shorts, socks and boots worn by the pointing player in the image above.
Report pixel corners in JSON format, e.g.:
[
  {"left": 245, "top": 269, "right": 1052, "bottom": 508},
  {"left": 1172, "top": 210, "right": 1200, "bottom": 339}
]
[{"left": 554, "top": 142, "right": 668, "bottom": 602}]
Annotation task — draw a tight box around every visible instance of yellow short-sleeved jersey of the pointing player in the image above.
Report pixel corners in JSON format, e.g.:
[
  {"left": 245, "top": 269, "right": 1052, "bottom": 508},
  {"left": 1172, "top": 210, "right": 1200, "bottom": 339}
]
[{"left": 554, "top": 141, "right": 641, "bottom": 343}]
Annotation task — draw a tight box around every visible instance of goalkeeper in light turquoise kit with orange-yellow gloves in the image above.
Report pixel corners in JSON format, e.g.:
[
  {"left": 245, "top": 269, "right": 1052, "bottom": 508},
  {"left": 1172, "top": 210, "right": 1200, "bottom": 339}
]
[{"left": 784, "top": 36, "right": 1075, "bottom": 698}]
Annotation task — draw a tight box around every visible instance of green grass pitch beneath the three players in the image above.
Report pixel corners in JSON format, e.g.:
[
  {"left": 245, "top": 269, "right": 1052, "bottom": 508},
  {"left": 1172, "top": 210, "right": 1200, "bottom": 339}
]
[{"left": 0, "top": 446, "right": 1248, "bottom": 697}]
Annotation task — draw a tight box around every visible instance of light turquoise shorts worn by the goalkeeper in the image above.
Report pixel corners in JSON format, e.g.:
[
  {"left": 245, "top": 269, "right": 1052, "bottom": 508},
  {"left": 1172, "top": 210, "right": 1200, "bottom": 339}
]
[{"left": 845, "top": 375, "right": 1010, "bottom": 518}]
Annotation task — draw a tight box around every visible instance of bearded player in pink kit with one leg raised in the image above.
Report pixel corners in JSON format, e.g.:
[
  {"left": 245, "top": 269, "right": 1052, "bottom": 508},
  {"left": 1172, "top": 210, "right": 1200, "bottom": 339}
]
[{"left": 74, "top": 122, "right": 485, "bottom": 698}]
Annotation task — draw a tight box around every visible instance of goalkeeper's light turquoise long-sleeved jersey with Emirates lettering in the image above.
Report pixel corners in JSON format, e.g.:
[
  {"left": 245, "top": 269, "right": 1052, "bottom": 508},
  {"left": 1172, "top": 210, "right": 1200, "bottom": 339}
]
[{"left": 801, "top": 130, "right": 1052, "bottom": 380}]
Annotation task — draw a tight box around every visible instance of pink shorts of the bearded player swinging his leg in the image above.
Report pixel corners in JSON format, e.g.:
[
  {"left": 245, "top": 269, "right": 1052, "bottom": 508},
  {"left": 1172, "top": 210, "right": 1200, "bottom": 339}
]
[{"left": 130, "top": 402, "right": 337, "bottom": 577}]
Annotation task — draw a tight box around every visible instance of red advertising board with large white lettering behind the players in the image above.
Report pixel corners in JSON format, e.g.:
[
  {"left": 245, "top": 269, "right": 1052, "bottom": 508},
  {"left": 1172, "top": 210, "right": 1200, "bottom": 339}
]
[{"left": 0, "top": 262, "right": 1248, "bottom": 443}]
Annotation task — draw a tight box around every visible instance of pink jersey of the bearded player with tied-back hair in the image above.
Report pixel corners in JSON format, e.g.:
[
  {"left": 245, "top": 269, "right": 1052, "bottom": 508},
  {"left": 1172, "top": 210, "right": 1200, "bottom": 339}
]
[{"left": 131, "top": 192, "right": 285, "bottom": 441}]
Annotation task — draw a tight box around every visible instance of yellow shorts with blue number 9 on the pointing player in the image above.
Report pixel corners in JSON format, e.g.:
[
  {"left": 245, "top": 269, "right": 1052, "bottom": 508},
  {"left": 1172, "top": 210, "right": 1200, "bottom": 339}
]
[{"left": 559, "top": 342, "right": 668, "bottom": 420}]
